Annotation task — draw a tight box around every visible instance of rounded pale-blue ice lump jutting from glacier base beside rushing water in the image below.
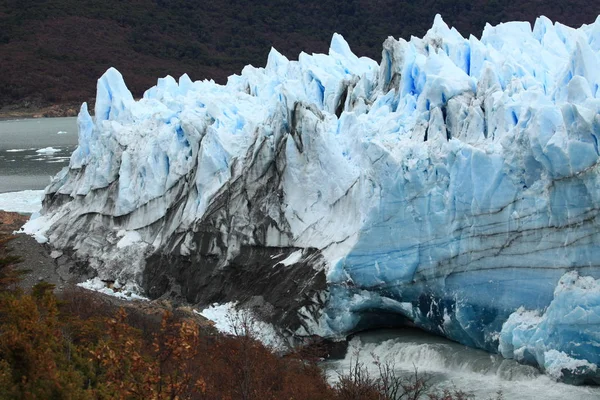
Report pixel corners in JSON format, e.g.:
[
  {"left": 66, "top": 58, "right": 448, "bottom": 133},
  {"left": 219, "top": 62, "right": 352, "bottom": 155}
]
[{"left": 498, "top": 271, "right": 600, "bottom": 382}]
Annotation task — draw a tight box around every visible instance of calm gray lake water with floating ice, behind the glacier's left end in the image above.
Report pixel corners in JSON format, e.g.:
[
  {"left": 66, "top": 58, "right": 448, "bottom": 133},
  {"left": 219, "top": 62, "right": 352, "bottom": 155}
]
[{"left": 0, "top": 118, "right": 77, "bottom": 193}]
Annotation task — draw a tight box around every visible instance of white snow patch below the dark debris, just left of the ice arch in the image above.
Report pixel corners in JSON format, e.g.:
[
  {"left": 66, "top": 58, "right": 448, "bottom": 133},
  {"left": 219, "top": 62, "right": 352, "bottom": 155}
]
[{"left": 196, "top": 302, "right": 286, "bottom": 350}]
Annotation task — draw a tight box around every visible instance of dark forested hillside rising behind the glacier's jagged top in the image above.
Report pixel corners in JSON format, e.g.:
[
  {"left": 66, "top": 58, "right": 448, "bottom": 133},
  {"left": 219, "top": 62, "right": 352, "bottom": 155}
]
[{"left": 0, "top": 0, "right": 600, "bottom": 107}]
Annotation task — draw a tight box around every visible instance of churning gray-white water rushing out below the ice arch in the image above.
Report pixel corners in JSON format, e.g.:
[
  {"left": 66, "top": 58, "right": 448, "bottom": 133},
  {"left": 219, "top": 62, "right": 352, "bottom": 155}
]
[{"left": 324, "top": 328, "right": 600, "bottom": 400}]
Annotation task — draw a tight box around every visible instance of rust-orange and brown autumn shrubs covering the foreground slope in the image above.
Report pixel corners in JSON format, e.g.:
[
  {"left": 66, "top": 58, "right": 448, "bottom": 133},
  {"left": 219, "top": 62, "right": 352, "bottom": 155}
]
[{"left": 0, "top": 270, "right": 335, "bottom": 400}]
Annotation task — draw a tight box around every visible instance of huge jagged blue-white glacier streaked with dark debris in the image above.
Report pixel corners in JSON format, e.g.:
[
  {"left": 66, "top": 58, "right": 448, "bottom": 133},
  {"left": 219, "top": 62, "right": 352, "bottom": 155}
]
[{"left": 26, "top": 16, "right": 600, "bottom": 383}]
